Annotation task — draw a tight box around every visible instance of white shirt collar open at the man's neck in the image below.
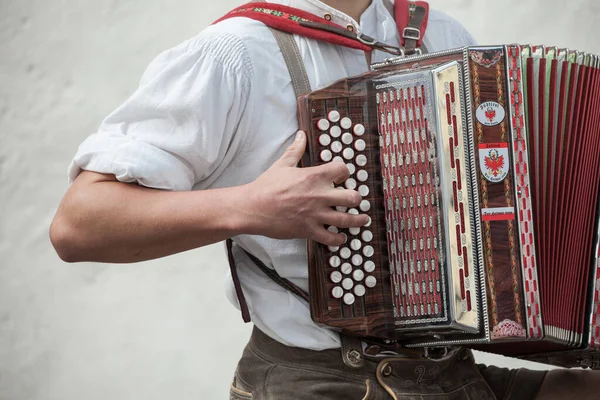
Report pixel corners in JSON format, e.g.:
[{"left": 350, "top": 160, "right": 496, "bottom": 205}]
[{"left": 269, "top": 0, "right": 387, "bottom": 33}]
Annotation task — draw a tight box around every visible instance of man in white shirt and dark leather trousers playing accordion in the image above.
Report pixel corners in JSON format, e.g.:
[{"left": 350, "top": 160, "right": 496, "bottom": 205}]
[{"left": 51, "top": 0, "right": 591, "bottom": 399}]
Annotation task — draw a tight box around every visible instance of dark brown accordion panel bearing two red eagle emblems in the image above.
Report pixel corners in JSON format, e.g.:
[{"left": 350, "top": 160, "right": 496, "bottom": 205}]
[{"left": 470, "top": 47, "right": 533, "bottom": 341}]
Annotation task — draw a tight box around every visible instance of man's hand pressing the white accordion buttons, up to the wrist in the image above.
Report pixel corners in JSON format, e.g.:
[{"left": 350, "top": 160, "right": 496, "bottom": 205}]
[{"left": 245, "top": 131, "right": 369, "bottom": 246}]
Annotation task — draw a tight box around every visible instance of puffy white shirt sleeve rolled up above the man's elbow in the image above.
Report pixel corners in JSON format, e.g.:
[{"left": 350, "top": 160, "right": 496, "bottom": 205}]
[{"left": 68, "top": 31, "right": 252, "bottom": 190}]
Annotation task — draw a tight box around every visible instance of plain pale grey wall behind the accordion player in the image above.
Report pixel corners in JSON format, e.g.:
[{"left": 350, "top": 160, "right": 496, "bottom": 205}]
[{"left": 0, "top": 0, "right": 600, "bottom": 400}]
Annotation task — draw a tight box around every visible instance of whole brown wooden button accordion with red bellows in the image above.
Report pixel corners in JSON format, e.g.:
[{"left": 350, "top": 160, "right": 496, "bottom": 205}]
[{"left": 299, "top": 45, "right": 600, "bottom": 368}]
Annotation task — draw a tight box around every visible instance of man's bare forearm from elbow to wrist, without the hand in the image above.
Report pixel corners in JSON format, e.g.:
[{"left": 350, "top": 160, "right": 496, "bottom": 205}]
[{"left": 50, "top": 172, "right": 250, "bottom": 263}]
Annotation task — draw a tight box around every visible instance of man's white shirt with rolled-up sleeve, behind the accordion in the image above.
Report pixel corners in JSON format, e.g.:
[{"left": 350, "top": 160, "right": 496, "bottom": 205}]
[{"left": 69, "top": 0, "right": 474, "bottom": 350}]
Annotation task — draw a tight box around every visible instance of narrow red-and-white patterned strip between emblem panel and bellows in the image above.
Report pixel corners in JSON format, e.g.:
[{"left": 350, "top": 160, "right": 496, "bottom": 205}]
[{"left": 506, "top": 45, "right": 543, "bottom": 339}]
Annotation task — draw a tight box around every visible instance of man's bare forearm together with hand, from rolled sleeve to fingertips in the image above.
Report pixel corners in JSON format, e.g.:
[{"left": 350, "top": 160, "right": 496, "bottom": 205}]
[{"left": 50, "top": 132, "right": 369, "bottom": 263}]
